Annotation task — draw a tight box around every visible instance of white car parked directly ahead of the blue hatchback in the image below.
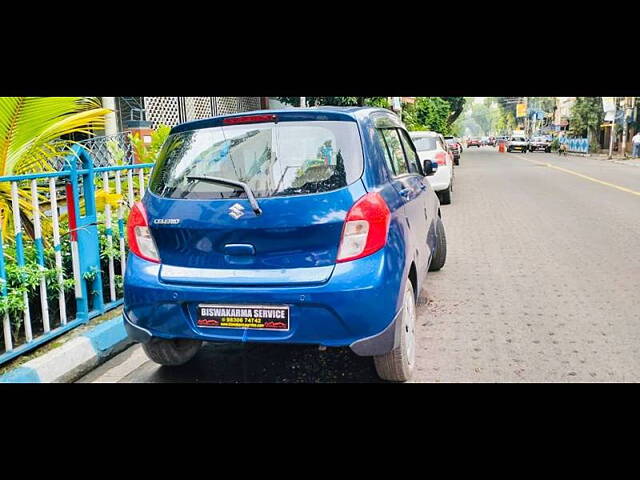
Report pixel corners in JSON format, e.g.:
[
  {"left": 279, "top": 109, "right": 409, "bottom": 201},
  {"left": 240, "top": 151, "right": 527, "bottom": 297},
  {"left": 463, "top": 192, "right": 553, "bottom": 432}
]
[{"left": 409, "top": 132, "right": 454, "bottom": 205}]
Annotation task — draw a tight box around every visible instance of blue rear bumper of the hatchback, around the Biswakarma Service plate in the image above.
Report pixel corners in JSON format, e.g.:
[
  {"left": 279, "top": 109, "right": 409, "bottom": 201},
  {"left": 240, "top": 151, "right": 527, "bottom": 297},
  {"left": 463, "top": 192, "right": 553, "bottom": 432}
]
[{"left": 124, "top": 247, "right": 406, "bottom": 355}]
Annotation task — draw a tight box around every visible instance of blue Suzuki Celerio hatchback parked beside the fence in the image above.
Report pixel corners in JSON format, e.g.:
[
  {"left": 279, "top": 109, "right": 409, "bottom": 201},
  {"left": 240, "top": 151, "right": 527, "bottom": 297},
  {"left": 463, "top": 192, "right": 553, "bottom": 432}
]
[{"left": 124, "top": 107, "right": 446, "bottom": 381}]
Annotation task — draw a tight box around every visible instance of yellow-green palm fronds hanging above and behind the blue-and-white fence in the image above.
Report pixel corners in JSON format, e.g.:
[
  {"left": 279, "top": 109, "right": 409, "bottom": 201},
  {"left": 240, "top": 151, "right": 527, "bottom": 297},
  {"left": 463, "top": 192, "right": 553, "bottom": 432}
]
[{"left": 0, "top": 97, "right": 111, "bottom": 238}]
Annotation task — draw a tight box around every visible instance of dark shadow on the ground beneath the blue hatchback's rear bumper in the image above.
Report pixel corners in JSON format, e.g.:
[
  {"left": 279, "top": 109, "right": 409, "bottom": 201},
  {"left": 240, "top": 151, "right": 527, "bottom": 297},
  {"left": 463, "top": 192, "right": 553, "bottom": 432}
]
[{"left": 140, "top": 343, "right": 380, "bottom": 383}]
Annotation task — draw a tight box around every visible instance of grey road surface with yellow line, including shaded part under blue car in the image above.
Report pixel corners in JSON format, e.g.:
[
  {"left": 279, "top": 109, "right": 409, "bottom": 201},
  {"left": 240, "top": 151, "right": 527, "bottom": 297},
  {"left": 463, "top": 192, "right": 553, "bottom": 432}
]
[{"left": 80, "top": 147, "right": 640, "bottom": 382}]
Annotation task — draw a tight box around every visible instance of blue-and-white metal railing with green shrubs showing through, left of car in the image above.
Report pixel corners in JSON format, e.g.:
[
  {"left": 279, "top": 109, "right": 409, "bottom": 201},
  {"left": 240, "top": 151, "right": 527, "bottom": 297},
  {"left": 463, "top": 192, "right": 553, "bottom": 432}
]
[{"left": 0, "top": 145, "right": 153, "bottom": 364}]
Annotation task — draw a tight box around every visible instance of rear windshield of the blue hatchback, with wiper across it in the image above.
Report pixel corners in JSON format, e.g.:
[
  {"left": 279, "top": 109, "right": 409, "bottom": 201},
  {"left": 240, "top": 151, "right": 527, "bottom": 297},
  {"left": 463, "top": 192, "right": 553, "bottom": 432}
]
[{"left": 149, "top": 121, "right": 363, "bottom": 199}]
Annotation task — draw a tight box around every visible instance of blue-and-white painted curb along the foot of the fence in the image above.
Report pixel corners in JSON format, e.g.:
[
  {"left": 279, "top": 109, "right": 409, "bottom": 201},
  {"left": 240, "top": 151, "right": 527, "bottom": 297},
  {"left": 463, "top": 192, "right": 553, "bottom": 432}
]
[{"left": 0, "top": 315, "right": 133, "bottom": 383}]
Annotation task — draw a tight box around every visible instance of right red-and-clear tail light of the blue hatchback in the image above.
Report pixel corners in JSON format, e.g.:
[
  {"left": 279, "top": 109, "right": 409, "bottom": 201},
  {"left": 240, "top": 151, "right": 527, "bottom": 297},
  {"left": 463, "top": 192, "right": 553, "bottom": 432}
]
[{"left": 337, "top": 193, "right": 391, "bottom": 263}]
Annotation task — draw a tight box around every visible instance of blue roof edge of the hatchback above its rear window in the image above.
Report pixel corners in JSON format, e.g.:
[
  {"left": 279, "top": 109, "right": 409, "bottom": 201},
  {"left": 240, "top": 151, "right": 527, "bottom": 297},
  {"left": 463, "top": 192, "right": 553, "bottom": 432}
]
[{"left": 171, "top": 106, "right": 401, "bottom": 134}]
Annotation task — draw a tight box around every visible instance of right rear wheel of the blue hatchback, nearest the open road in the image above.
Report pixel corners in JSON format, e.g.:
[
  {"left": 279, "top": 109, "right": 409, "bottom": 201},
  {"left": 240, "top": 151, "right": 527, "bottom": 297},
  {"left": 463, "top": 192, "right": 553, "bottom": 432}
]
[{"left": 373, "top": 278, "right": 416, "bottom": 382}]
